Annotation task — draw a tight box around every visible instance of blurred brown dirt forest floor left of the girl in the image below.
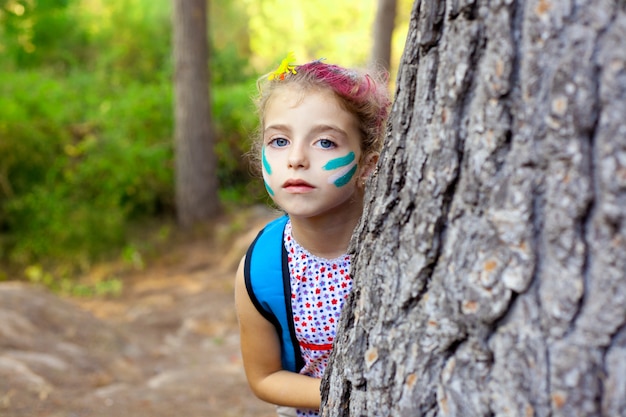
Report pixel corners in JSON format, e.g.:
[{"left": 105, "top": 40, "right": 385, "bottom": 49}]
[{"left": 0, "top": 208, "right": 275, "bottom": 417}]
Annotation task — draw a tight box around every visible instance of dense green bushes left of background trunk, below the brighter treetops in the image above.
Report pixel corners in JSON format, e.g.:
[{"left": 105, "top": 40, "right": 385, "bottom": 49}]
[{"left": 0, "top": 71, "right": 173, "bottom": 264}]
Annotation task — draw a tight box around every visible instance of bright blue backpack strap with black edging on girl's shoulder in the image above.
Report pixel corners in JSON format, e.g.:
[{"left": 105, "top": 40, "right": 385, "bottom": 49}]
[{"left": 244, "top": 216, "right": 304, "bottom": 372}]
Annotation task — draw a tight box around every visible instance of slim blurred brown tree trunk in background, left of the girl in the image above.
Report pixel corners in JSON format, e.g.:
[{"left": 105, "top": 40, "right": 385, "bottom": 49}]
[{"left": 173, "top": 0, "right": 219, "bottom": 226}]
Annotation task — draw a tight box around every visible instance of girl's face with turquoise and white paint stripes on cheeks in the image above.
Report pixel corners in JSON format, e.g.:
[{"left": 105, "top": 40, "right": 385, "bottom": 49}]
[{"left": 262, "top": 86, "right": 375, "bottom": 217}]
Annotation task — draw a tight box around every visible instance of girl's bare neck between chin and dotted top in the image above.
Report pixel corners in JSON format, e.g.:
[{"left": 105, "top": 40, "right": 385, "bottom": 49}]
[{"left": 290, "top": 204, "right": 361, "bottom": 259}]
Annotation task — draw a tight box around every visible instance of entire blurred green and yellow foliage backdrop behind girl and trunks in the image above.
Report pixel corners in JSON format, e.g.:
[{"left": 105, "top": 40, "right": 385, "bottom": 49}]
[{"left": 0, "top": 0, "right": 411, "bottom": 281}]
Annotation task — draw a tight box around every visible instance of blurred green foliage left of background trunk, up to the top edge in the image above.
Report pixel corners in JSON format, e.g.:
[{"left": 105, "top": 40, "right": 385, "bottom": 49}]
[{"left": 0, "top": 0, "right": 173, "bottom": 274}]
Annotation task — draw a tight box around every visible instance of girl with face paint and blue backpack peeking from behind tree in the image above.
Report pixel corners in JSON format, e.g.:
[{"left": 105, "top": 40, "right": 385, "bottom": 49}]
[{"left": 235, "top": 54, "right": 390, "bottom": 416}]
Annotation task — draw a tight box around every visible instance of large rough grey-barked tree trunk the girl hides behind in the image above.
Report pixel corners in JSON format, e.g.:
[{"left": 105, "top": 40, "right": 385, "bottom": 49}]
[{"left": 323, "top": 0, "right": 626, "bottom": 417}]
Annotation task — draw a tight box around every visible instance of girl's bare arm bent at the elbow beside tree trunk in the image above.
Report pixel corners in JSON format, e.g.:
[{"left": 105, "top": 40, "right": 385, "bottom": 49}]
[{"left": 235, "top": 256, "right": 321, "bottom": 410}]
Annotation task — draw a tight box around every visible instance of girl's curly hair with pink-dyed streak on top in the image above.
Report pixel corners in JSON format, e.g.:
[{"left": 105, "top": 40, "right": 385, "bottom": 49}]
[{"left": 254, "top": 60, "right": 391, "bottom": 162}]
